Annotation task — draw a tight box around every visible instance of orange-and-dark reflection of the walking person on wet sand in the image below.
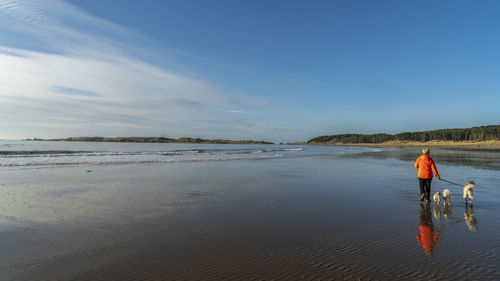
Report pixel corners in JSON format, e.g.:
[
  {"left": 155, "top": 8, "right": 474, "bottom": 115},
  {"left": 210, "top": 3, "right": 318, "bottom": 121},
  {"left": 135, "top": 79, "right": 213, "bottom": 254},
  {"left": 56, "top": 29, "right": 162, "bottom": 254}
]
[{"left": 417, "top": 203, "right": 441, "bottom": 255}]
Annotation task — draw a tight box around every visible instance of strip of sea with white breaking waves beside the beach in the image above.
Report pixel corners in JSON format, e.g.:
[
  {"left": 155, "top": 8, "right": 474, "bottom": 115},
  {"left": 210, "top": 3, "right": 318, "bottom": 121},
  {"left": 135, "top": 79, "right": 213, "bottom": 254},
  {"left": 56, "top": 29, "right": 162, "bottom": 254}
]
[{"left": 0, "top": 141, "right": 380, "bottom": 167}]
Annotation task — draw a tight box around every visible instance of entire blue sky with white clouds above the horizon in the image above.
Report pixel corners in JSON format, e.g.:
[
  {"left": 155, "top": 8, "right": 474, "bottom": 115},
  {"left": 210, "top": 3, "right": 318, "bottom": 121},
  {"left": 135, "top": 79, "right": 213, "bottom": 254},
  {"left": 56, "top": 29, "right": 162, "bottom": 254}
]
[{"left": 0, "top": 0, "right": 500, "bottom": 142}]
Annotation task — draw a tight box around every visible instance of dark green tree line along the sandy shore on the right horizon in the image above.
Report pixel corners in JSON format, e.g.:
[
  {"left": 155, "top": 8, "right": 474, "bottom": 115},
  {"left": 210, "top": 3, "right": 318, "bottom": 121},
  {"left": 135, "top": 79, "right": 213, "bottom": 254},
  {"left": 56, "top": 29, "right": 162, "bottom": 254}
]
[{"left": 307, "top": 125, "right": 500, "bottom": 143}]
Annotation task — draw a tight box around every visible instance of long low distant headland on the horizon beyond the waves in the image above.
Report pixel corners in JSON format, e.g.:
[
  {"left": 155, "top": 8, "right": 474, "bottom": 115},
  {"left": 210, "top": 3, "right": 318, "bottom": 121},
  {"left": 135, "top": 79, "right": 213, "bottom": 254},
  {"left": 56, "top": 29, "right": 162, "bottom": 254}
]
[{"left": 27, "top": 137, "right": 274, "bottom": 144}]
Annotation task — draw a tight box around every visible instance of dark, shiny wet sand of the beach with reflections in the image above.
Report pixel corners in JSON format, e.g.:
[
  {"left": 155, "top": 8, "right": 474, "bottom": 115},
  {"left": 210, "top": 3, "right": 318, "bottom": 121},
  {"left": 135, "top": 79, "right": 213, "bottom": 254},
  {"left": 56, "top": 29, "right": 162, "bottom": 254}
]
[{"left": 0, "top": 150, "right": 500, "bottom": 280}]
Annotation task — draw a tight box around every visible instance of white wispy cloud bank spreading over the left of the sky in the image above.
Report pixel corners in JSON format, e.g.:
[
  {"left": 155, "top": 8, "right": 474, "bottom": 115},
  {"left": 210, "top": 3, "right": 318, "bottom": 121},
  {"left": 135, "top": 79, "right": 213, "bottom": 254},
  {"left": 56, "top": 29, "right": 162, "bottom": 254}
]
[{"left": 0, "top": 0, "right": 278, "bottom": 140}]
